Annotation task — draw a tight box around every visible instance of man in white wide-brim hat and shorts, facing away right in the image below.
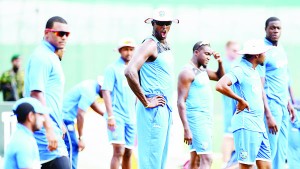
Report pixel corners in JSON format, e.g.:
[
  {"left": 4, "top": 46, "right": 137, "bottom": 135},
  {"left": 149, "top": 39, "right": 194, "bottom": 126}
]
[{"left": 216, "top": 40, "right": 272, "bottom": 169}]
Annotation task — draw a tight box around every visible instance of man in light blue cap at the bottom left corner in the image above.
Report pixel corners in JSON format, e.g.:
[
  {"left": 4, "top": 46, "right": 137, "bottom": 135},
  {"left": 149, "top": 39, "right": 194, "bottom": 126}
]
[{"left": 4, "top": 97, "right": 50, "bottom": 169}]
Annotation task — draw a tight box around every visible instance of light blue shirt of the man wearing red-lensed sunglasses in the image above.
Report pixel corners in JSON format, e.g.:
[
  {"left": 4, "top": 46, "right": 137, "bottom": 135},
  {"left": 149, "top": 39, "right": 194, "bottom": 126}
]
[{"left": 25, "top": 40, "right": 68, "bottom": 162}]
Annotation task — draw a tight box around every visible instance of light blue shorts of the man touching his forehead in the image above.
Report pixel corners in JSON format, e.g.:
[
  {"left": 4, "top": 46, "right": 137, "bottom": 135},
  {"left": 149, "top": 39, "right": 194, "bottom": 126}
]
[{"left": 187, "top": 112, "right": 212, "bottom": 154}]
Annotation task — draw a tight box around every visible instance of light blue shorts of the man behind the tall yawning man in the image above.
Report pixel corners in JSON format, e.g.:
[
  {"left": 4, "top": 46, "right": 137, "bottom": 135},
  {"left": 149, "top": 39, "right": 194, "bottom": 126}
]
[{"left": 107, "top": 117, "right": 136, "bottom": 149}]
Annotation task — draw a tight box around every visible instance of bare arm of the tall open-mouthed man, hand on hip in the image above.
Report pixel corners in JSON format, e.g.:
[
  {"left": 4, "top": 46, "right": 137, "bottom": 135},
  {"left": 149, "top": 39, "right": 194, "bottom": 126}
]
[{"left": 124, "top": 40, "right": 164, "bottom": 108}]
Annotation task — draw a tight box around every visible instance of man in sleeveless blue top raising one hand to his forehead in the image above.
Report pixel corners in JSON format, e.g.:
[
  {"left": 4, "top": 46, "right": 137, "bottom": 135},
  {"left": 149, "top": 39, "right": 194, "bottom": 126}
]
[{"left": 177, "top": 41, "right": 224, "bottom": 169}]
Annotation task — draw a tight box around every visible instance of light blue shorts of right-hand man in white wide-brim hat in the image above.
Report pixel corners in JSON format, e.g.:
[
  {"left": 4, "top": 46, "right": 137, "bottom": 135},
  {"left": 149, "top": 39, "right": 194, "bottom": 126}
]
[{"left": 233, "top": 129, "right": 271, "bottom": 165}]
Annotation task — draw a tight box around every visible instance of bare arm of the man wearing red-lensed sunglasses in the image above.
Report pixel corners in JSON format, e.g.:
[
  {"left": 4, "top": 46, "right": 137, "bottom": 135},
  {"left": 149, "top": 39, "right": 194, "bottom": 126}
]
[{"left": 30, "top": 90, "right": 58, "bottom": 151}]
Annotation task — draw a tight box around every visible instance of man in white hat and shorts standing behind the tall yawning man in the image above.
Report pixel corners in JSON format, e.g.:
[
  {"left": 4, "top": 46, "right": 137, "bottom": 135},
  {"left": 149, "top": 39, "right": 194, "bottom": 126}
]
[{"left": 101, "top": 38, "right": 136, "bottom": 169}]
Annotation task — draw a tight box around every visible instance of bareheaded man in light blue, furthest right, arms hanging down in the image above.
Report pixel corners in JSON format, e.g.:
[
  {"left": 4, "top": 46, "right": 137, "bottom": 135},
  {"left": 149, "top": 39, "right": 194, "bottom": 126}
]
[{"left": 258, "top": 17, "right": 295, "bottom": 169}]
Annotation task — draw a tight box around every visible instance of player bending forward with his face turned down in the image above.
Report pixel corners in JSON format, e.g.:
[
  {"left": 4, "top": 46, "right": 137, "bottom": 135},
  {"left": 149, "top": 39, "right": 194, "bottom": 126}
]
[{"left": 62, "top": 76, "right": 104, "bottom": 169}]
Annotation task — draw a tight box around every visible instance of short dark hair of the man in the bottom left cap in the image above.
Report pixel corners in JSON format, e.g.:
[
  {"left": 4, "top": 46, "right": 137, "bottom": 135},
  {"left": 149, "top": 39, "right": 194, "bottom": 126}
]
[{"left": 14, "top": 103, "right": 35, "bottom": 123}]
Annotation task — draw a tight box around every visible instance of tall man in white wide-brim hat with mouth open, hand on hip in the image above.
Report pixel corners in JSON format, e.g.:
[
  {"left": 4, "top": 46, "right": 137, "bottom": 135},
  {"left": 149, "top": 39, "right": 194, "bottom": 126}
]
[{"left": 125, "top": 8, "right": 179, "bottom": 169}]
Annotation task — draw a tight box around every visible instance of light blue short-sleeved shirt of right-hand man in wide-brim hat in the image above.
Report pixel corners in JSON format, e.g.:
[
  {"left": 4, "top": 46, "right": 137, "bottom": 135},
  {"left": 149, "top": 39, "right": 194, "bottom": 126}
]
[{"left": 226, "top": 58, "right": 266, "bottom": 132}]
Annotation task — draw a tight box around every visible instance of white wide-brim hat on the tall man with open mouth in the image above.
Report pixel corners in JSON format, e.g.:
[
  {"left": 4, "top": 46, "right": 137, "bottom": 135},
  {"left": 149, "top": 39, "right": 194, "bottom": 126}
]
[{"left": 144, "top": 8, "right": 179, "bottom": 24}]
